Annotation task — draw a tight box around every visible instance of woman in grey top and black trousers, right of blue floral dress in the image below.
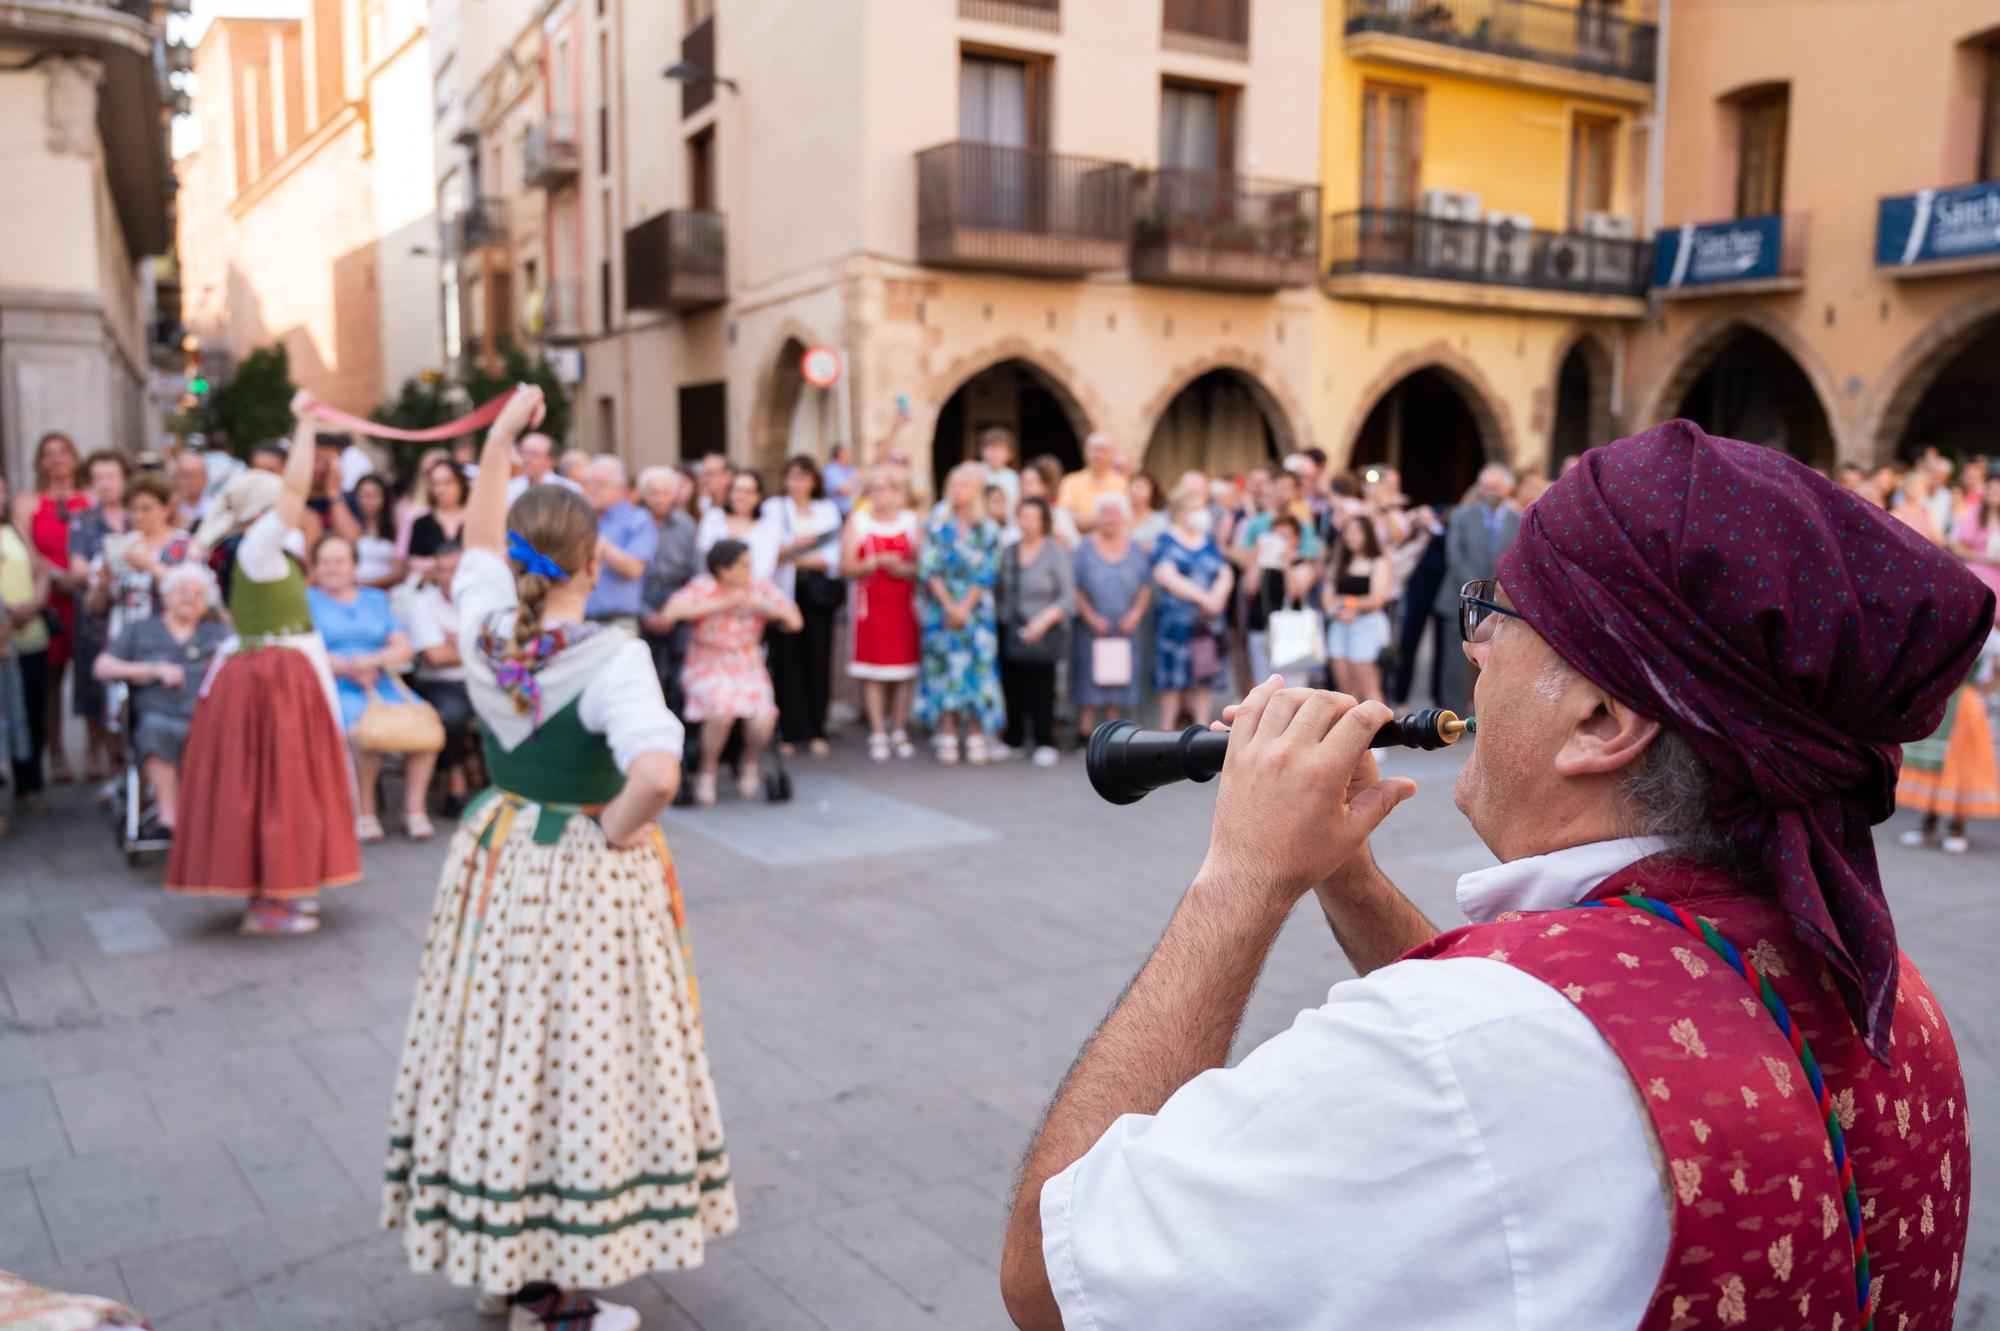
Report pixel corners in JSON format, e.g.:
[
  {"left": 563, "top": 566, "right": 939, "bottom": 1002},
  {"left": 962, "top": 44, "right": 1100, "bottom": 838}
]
[{"left": 1000, "top": 500, "right": 1076, "bottom": 767}]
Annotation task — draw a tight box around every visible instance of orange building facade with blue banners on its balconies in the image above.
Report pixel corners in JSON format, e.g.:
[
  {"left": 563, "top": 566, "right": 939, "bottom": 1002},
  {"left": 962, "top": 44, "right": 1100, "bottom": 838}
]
[{"left": 1628, "top": 0, "right": 2000, "bottom": 466}]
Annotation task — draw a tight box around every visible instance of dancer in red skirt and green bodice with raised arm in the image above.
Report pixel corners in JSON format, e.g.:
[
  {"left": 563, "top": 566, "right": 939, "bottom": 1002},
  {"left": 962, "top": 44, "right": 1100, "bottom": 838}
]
[{"left": 166, "top": 392, "right": 362, "bottom": 933}]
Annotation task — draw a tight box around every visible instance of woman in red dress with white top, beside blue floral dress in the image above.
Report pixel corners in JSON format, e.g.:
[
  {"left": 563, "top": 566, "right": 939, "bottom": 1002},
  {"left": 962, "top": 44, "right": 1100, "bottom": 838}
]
[{"left": 842, "top": 470, "right": 922, "bottom": 763}]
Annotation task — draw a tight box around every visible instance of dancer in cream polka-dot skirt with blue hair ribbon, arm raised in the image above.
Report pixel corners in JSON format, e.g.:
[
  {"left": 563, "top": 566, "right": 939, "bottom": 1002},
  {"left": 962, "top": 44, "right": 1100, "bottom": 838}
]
[{"left": 382, "top": 388, "right": 736, "bottom": 1331}]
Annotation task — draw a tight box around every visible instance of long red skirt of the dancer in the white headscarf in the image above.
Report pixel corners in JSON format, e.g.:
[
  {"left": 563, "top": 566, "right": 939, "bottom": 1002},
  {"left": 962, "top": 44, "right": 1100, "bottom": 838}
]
[{"left": 166, "top": 648, "right": 362, "bottom": 897}]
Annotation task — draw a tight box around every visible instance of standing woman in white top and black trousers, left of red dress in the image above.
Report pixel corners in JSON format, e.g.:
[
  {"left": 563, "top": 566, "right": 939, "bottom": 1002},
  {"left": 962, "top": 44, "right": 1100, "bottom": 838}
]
[{"left": 764, "top": 456, "right": 848, "bottom": 757}]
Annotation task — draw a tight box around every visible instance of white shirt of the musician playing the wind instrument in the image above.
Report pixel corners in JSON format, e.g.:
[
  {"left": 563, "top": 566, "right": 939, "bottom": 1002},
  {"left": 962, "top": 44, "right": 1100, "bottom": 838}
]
[{"left": 1042, "top": 839, "right": 1670, "bottom": 1331}]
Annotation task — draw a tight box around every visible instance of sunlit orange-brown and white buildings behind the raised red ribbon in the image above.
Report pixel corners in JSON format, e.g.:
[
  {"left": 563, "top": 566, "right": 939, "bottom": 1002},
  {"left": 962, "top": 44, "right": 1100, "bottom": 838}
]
[{"left": 178, "top": 0, "right": 442, "bottom": 414}]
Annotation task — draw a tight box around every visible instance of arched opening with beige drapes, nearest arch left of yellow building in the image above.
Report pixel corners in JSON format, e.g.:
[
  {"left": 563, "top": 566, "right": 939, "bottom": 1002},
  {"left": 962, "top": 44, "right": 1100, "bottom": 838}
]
[{"left": 1140, "top": 354, "right": 1310, "bottom": 481}]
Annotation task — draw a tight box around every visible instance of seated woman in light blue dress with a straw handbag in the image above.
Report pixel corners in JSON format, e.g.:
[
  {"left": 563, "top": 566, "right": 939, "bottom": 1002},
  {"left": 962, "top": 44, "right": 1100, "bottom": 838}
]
[{"left": 306, "top": 536, "right": 444, "bottom": 845}]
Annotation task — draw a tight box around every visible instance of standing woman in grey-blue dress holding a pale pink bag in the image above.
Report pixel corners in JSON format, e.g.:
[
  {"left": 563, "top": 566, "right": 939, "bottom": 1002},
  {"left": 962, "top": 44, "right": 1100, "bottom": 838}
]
[{"left": 1070, "top": 494, "right": 1152, "bottom": 739}]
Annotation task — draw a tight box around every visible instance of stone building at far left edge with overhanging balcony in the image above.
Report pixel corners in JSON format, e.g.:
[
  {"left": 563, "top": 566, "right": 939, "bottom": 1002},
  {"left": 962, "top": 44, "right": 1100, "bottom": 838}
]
[{"left": 0, "top": 0, "right": 172, "bottom": 479}]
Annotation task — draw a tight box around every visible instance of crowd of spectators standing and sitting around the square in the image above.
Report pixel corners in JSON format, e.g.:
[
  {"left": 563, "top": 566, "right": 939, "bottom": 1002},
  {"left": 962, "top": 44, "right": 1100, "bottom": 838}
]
[{"left": 0, "top": 415, "right": 2000, "bottom": 839}]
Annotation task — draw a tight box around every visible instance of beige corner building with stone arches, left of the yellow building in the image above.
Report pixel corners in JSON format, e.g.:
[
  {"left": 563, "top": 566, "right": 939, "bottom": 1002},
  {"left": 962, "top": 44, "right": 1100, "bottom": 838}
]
[{"left": 446, "top": 0, "right": 1320, "bottom": 480}]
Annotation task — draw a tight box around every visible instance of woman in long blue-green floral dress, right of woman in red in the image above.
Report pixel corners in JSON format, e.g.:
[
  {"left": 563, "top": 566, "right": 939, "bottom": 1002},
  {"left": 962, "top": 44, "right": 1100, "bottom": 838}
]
[{"left": 916, "top": 462, "right": 1006, "bottom": 767}]
